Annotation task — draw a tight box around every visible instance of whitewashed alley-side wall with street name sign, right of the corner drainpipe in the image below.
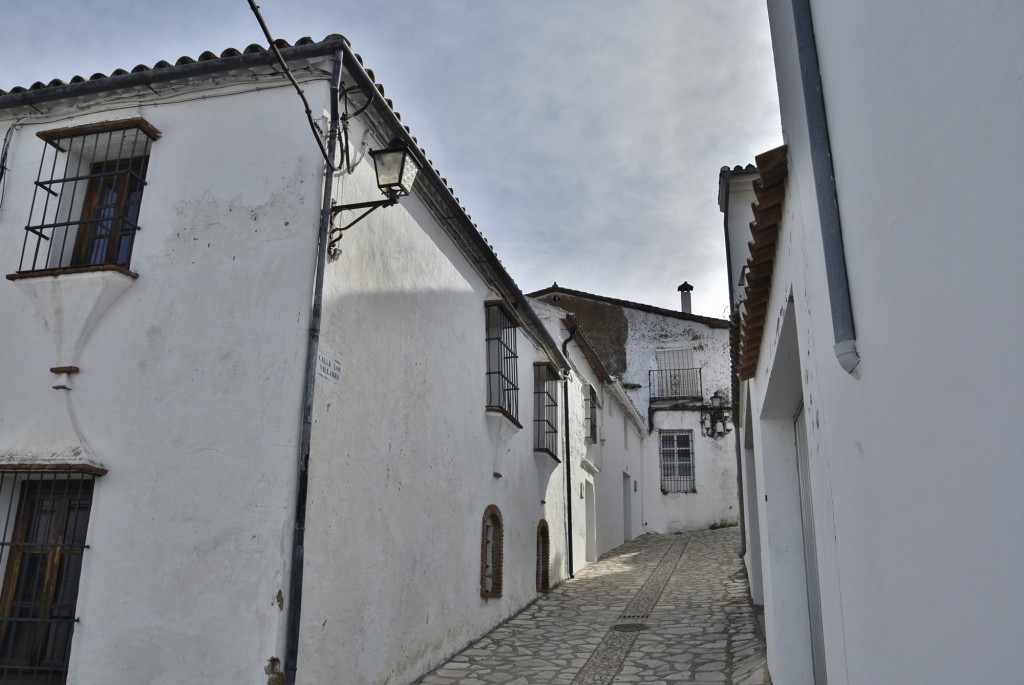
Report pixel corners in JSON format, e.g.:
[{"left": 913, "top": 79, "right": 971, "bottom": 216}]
[{"left": 299, "top": 112, "right": 583, "bottom": 685}]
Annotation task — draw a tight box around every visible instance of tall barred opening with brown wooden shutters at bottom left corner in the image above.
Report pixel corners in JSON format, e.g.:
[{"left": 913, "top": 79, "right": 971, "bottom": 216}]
[{"left": 0, "top": 471, "right": 94, "bottom": 685}]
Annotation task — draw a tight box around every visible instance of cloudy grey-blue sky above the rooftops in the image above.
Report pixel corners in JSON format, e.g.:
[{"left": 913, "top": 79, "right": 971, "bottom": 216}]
[{"left": 0, "top": 0, "right": 781, "bottom": 316}]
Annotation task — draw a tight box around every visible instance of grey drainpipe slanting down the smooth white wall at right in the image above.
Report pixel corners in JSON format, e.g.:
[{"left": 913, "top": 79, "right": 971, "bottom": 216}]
[{"left": 793, "top": 0, "right": 860, "bottom": 378}]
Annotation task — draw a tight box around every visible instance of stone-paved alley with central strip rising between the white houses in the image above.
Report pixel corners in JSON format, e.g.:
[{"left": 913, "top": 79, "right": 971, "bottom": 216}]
[{"left": 417, "top": 528, "right": 770, "bottom": 685}]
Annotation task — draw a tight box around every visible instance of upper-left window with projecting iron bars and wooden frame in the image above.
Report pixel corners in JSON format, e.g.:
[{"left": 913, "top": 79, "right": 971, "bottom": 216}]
[{"left": 12, "top": 117, "right": 160, "bottom": 273}]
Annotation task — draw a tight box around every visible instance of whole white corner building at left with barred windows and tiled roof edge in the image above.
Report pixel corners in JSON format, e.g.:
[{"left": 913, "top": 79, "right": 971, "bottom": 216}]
[{"left": 0, "top": 36, "right": 642, "bottom": 685}]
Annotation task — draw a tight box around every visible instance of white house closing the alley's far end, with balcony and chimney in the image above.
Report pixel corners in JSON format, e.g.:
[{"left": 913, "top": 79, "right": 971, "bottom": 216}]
[{"left": 530, "top": 284, "right": 738, "bottom": 532}]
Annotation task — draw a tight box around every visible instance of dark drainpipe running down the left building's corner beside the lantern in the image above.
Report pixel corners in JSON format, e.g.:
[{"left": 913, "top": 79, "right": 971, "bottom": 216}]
[{"left": 285, "top": 49, "right": 342, "bottom": 685}]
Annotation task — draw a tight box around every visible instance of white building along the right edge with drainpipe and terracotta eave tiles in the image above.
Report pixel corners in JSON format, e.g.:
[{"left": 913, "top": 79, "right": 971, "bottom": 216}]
[{"left": 721, "top": 0, "right": 1024, "bottom": 685}]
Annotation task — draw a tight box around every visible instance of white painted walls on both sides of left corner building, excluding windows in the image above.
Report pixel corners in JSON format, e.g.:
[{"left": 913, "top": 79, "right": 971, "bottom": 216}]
[{"left": 0, "top": 40, "right": 643, "bottom": 685}]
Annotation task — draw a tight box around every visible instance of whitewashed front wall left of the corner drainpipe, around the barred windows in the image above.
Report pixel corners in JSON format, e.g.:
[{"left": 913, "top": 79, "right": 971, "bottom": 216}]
[{"left": 0, "top": 80, "right": 326, "bottom": 685}]
